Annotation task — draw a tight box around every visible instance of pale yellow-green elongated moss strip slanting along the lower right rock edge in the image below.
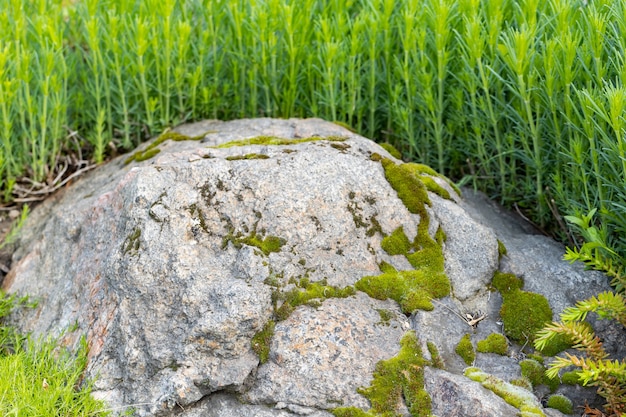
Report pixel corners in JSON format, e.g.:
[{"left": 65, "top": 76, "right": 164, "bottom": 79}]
[{"left": 465, "top": 367, "right": 545, "bottom": 417}]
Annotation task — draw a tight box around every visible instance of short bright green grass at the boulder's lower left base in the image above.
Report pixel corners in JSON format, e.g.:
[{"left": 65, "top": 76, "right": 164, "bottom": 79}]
[{"left": 0, "top": 291, "right": 108, "bottom": 417}]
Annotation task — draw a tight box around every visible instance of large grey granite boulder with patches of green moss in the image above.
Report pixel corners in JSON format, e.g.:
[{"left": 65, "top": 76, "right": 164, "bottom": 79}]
[{"left": 2, "top": 119, "right": 620, "bottom": 417}]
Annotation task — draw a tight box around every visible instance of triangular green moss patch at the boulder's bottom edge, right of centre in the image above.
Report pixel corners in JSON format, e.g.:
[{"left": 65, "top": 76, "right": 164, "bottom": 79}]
[{"left": 333, "top": 332, "right": 431, "bottom": 417}]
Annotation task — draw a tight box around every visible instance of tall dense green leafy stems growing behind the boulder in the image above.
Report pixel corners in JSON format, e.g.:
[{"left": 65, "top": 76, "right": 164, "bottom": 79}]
[{"left": 0, "top": 0, "right": 626, "bottom": 276}]
